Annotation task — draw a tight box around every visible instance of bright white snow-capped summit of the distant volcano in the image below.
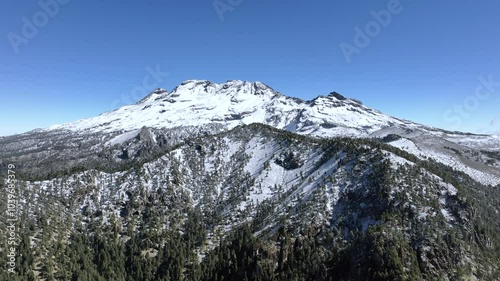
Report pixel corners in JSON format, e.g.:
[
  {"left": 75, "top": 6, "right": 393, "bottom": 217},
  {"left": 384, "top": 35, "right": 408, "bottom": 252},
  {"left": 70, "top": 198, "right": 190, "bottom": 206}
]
[{"left": 48, "top": 80, "right": 431, "bottom": 136}]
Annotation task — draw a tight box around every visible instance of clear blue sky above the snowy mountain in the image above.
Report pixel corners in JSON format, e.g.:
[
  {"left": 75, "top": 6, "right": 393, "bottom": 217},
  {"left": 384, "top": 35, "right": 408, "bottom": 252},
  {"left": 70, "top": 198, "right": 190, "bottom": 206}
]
[{"left": 0, "top": 0, "right": 500, "bottom": 135}]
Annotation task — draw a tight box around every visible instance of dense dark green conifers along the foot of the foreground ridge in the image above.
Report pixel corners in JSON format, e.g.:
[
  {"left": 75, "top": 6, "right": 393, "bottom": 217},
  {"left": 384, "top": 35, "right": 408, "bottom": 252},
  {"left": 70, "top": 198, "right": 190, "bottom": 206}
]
[{"left": 0, "top": 219, "right": 488, "bottom": 281}]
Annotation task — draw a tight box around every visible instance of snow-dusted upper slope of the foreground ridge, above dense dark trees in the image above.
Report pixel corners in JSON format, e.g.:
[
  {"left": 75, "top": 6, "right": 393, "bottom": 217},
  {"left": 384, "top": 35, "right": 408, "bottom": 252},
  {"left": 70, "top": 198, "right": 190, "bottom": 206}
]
[{"left": 11, "top": 124, "right": 499, "bottom": 280}]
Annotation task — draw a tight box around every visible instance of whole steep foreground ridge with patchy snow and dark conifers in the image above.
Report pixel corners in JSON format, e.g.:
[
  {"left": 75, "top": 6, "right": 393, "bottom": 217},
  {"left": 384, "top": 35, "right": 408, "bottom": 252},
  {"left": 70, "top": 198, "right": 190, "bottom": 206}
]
[{"left": 0, "top": 123, "right": 500, "bottom": 280}]
